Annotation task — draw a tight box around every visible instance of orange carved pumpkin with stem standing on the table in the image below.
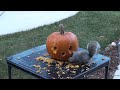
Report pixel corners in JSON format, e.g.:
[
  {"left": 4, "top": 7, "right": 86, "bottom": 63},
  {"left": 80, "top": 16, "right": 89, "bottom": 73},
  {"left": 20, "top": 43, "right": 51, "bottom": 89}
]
[{"left": 46, "top": 24, "right": 79, "bottom": 61}]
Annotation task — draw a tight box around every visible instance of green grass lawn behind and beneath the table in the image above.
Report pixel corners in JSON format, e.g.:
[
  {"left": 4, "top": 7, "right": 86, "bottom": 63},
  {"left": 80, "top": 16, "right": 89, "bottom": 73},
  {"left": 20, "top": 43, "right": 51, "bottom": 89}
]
[{"left": 0, "top": 11, "right": 120, "bottom": 79}]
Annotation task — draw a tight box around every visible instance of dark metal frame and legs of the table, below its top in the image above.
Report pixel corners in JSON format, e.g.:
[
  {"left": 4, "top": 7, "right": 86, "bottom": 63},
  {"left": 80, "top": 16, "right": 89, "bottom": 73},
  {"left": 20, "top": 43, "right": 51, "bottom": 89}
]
[{"left": 6, "top": 44, "right": 109, "bottom": 79}]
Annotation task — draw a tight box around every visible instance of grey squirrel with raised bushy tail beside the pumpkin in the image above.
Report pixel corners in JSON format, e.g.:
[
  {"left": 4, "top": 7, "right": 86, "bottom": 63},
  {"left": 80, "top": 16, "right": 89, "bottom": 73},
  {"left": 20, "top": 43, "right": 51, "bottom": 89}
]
[{"left": 68, "top": 41, "right": 101, "bottom": 65}]
